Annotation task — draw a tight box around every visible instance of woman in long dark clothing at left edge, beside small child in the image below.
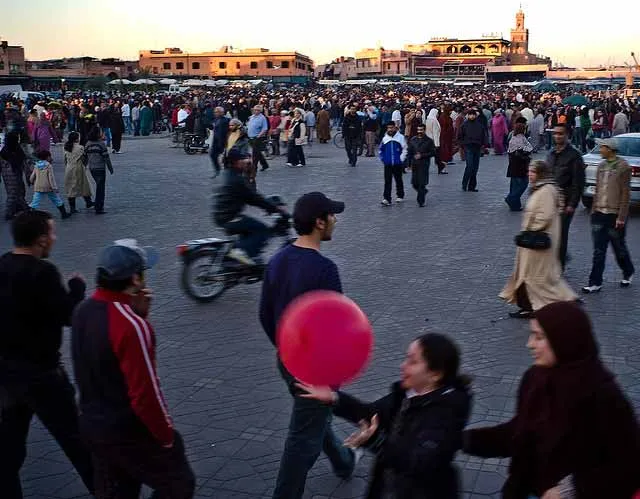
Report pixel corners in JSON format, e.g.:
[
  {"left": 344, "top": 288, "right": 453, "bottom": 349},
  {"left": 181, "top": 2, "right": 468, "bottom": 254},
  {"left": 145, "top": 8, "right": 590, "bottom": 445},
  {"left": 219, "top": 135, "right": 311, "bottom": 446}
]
[{"left": 0, "top": 132, "right": 31, "bottom": 220}]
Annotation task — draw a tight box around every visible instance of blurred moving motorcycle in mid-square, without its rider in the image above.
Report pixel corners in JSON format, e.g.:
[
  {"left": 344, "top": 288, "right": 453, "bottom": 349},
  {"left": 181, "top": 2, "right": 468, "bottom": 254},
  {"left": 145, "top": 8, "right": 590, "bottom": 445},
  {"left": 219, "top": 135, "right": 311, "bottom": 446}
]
[{"left": 177, "top": 196, "right": 296, "bottom": 303}]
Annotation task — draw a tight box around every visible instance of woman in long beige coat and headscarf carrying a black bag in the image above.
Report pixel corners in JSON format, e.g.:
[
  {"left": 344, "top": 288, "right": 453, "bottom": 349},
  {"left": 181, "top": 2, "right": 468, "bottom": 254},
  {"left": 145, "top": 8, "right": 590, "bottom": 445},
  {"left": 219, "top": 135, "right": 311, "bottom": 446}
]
[{"left": 500, "top": 160, "right": 577, "bottom": 319}]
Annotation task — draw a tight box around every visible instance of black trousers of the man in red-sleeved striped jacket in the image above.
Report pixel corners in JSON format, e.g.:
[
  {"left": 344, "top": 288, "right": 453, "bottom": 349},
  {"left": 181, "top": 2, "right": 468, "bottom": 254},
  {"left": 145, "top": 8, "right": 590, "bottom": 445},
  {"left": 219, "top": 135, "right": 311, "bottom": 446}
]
[{"left": 86, "top": 432, "right": 196, "bottom": 499}]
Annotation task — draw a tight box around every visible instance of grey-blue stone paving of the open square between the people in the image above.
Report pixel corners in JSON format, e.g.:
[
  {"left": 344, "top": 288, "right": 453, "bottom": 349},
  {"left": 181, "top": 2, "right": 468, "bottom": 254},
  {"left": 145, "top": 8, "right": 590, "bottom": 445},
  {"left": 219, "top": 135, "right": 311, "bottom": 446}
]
[{"left": 0, "top": 134, "right": 640, "bottom": 499}]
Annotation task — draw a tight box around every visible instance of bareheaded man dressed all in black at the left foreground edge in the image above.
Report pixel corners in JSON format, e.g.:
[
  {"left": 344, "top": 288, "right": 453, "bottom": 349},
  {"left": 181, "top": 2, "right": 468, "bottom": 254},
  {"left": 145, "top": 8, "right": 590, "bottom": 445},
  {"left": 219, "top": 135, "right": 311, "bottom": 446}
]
[{"left": 0, "top": 210, "right": 93, "bottom": 499}]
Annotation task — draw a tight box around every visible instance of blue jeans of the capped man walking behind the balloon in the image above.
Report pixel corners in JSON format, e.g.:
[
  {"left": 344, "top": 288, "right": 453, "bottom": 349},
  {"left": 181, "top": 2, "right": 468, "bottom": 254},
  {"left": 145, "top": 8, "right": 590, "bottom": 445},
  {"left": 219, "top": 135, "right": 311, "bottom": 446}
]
[{"left": 273, "top": 361, "right": 355, "bottom": 499}]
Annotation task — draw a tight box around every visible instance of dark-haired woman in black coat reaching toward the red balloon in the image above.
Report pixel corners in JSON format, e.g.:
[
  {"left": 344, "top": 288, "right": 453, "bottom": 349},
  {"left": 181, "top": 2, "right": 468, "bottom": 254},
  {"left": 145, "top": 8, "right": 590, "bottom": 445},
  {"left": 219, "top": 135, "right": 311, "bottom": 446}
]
[{"left": 298, "top": 334, "right": 471, "bottom": 499}]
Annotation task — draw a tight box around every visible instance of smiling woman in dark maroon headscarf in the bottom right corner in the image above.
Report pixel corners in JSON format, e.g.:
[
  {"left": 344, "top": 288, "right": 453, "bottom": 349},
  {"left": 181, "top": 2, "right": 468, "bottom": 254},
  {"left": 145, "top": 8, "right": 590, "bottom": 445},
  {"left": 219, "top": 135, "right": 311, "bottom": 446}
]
[{"left": 463, "top": 302, "right": 640, "bottom": 499}]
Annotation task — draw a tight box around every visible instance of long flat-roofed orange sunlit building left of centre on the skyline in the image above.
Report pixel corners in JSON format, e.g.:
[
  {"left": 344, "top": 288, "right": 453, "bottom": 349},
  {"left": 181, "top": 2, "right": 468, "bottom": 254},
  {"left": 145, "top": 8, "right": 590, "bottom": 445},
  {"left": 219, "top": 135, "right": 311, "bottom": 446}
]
[{"left": 138, "top": 47, "right": 313, "bottom": 78}]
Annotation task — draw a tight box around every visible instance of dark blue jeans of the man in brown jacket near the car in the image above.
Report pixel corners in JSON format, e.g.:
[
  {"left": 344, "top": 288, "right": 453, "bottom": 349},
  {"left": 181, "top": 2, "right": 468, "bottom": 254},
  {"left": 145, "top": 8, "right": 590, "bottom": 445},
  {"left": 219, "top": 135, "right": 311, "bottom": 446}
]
[{"left": 589, "top": 211, "right": 635, "bottom": 286}]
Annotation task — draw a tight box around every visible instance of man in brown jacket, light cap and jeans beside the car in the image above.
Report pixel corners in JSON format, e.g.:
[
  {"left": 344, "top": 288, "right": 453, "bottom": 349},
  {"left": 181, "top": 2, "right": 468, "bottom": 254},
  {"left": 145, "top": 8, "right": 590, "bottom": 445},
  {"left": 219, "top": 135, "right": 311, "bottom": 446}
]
[{"left": 582, "top": 138, "right": 635, "bottom": 293}]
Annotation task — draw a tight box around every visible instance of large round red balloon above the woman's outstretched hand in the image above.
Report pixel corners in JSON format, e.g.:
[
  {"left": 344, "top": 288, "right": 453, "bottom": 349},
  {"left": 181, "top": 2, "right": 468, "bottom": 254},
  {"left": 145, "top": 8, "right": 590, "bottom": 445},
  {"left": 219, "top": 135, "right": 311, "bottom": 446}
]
[{"left": 276, "top": 291, "right": 373, "bottom": 387}]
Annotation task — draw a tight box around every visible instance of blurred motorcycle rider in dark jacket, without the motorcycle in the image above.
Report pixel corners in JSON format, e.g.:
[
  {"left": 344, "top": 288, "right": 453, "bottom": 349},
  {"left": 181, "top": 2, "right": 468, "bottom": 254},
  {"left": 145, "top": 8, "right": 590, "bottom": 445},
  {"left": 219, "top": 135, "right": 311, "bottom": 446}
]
[{"left": 213, "top": 147, "right": 287, "bottom": 265}]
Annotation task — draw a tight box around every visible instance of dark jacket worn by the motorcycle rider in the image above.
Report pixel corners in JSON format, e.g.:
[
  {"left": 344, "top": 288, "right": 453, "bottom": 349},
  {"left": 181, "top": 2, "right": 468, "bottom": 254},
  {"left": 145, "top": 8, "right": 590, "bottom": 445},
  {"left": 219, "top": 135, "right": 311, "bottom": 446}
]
[{"left": 213, "top": 168, "right": 277, "bottom": 226}]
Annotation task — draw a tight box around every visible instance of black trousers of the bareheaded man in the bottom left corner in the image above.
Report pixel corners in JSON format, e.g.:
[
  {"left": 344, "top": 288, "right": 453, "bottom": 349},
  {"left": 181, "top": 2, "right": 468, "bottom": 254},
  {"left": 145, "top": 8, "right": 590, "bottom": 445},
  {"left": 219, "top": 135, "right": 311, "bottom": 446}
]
[{"left": 0, "top": 360, "right": 93, "bottom": 499}]
